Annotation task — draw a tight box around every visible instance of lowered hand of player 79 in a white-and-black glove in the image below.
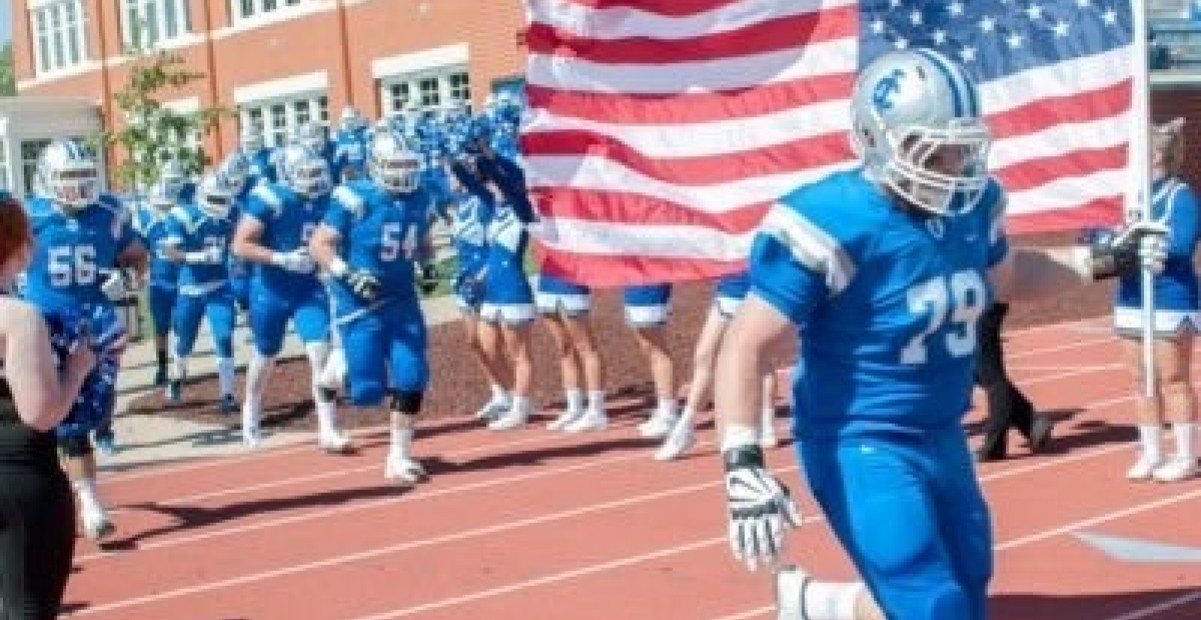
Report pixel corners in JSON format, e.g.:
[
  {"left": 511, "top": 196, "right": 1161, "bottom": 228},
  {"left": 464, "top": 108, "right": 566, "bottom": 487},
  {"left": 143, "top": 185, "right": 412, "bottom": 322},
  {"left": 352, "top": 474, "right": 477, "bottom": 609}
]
[{"left": 722, "top": 446, "right": 801, "bottom": 571}]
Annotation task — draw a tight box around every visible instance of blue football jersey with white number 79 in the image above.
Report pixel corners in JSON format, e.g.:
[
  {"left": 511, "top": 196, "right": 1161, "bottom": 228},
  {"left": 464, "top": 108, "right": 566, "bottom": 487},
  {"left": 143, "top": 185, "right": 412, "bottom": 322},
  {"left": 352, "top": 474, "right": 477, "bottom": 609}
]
[{"left": 749, "top": 169, "right": 1008, "bottom": 436}]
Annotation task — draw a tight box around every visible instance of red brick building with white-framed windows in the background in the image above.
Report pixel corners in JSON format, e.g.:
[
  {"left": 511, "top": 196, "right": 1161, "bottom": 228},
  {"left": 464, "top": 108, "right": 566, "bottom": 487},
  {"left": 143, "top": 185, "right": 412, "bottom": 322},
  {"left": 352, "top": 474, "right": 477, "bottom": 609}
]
[{"left": 8, "top": 0, "right": 525, "bottom": 187}]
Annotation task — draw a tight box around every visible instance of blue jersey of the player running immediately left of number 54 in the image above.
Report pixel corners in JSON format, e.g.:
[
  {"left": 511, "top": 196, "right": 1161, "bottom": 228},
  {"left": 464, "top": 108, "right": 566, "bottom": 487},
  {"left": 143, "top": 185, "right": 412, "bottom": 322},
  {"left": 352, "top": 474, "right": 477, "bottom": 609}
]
[{"left": 241, "top": 183, "right": 329, "bottom": 298}]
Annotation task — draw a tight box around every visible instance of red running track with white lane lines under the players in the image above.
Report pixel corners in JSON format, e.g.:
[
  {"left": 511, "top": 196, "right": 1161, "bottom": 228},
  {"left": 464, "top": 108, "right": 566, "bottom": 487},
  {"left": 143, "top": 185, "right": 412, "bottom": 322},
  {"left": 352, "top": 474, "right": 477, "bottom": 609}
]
[{"left": 60, "top": 321, "right": 1201, "bottom": 620}]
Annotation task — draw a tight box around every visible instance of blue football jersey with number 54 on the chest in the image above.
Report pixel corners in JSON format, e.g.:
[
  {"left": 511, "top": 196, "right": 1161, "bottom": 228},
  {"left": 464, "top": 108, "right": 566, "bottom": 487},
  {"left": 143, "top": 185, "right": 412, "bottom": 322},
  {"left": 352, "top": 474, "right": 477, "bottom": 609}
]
[{"left": 324, "top": 180, "right": 430, "bottom": 315}]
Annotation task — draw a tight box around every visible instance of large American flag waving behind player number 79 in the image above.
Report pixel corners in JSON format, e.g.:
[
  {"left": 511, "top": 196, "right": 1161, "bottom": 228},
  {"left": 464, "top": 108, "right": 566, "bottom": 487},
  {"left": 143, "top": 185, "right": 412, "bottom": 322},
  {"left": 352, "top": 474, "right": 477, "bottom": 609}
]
[{"left": 522, "top": 0, "right": 1134, "bottom": 286}]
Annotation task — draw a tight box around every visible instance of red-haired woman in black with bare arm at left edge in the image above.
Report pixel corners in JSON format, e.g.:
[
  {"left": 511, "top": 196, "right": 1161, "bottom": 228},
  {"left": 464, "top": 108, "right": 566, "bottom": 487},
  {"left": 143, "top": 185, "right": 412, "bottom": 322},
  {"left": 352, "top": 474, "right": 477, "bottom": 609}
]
[{"left": 0, "top": 193, "right": 96, "bottom": 620}]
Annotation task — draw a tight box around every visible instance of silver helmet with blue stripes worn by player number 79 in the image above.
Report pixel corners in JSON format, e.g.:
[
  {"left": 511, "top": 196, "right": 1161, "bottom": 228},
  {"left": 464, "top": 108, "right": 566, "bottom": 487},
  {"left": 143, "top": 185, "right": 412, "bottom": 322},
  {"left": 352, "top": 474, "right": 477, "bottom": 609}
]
[{"left": 852, "top": 49, "right": 992, "bottom": 215}]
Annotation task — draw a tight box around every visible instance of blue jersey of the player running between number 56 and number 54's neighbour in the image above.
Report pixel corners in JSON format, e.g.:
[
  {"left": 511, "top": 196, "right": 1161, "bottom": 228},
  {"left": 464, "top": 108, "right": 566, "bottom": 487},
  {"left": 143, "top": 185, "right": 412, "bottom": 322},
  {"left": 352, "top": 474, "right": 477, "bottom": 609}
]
[{"left": 163, "top": 203, "right": 233, "bottom": 294}]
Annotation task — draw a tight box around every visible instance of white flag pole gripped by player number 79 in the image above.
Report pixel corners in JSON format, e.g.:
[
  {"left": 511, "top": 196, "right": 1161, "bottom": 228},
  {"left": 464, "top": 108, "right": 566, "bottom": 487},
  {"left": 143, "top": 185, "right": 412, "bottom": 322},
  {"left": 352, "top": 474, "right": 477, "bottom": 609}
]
[{"left": 1125, "top": 0, "right": 1155, "bottom": 398}]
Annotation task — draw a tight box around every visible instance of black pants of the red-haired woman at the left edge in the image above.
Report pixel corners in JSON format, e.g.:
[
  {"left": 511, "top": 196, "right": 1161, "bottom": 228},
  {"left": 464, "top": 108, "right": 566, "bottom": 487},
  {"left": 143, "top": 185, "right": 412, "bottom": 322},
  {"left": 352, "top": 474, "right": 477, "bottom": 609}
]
[{"left": 0, "top": 463, "right": 76, "bottom": 620}]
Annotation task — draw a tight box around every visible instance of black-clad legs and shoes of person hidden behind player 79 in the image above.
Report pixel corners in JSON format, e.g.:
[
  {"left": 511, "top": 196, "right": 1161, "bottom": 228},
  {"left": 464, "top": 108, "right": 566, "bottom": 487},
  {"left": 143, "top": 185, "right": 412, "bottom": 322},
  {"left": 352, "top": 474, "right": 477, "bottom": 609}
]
[{"left": 976, "top": 303, "right": 1034, "bottom": 457}]
